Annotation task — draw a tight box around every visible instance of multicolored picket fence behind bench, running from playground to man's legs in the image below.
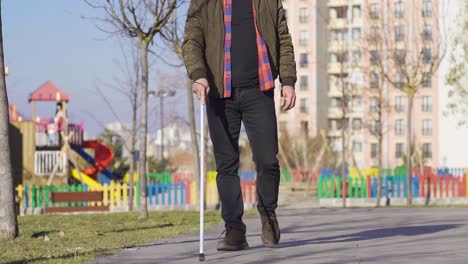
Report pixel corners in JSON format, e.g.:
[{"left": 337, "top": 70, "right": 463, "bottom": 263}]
[{"left": 16, "top": 179, "right": 257, "bottom": 212}]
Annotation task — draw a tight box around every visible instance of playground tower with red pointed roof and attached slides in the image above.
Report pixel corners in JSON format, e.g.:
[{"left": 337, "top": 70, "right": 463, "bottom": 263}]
[{"left": 9, "top": 81, "right": 119, "bottom": 187}]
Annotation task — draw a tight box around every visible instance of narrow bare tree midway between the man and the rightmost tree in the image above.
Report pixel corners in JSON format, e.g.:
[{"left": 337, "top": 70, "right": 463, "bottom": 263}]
[{"left": 327, "top": 3, "right": 363, "bottom": 207}]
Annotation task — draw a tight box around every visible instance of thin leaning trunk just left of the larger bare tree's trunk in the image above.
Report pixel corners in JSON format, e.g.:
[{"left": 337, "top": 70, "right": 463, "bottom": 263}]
[{"left": 128, "top": 82, "right": 140, "bottom": 211}]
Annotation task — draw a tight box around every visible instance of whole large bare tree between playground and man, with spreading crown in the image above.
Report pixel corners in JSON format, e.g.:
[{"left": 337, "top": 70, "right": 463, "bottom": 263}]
[{"left": 85, "top": 0, "right": 178, "bottom": 218}]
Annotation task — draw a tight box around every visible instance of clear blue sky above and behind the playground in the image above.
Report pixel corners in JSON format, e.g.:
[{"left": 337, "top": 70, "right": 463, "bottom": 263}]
[{"left": 2, "top": 0, "right": 186, "bottom": 136}]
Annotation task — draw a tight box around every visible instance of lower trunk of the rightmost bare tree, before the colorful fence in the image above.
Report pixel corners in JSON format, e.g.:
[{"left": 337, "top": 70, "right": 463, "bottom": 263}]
[{"left": 406, "top": 95, "right": 414, "bottom": 205}]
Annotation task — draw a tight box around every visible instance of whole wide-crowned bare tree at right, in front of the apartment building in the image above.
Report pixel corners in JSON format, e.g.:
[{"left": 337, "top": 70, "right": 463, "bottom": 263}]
[{"left": 368, "top": 0, "right": 446, "bottom": 205}]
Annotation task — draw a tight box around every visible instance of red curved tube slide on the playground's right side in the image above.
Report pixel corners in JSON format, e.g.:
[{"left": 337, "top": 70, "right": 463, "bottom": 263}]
[{"left": 82, "top": 140, "right": 114, "bottom": 179}]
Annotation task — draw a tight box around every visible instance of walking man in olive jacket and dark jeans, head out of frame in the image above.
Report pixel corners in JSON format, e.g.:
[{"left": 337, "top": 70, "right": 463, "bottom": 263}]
[{"left": 183, "top": 0, "right": 297, "bottom": 250}]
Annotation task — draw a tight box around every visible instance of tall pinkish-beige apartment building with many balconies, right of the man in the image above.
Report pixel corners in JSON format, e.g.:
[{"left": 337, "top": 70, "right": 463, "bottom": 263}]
[{"left": 278, "top": 0, "right": 443, "bottom": 167}]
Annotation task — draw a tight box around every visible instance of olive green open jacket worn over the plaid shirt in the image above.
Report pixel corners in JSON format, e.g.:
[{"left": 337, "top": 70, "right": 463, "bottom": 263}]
[{"left": 182, "top": 0, "right": 297, "bottom": 97}]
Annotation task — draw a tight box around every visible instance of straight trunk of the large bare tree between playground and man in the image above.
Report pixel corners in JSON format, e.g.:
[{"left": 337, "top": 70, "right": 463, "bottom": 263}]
[{"left": 138, "top": 40, "right": 149, "bottom": 219}]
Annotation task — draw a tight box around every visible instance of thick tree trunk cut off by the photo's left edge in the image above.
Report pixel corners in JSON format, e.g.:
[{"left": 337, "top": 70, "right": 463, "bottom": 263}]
[{"left": 0, "top": 1, "right": 18, "bottom": 239}]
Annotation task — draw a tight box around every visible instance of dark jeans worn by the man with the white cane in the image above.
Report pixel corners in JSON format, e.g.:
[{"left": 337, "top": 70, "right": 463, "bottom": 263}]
[{"left": 206, "top": 86, "right": 280, "bottom": 228}]
